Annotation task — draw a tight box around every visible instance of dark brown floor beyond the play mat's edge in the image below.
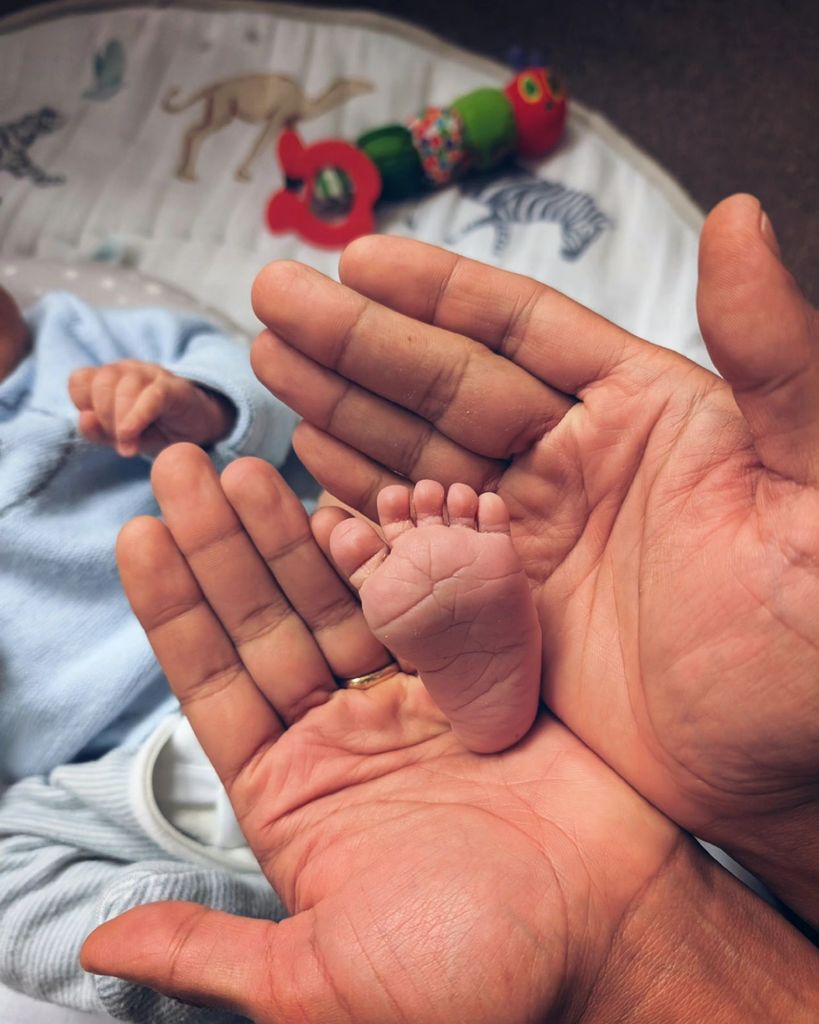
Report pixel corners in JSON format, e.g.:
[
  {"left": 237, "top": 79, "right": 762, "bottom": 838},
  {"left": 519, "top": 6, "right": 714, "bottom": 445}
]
[{"left": 6, "top": 0, "right": 819, "bottom": 302}]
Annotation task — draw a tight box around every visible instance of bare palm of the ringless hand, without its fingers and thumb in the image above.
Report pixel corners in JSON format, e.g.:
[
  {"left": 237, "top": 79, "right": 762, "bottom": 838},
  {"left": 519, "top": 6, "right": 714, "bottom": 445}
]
[{"left": 499, "top": 339, "right": 819, "bottom": 842}]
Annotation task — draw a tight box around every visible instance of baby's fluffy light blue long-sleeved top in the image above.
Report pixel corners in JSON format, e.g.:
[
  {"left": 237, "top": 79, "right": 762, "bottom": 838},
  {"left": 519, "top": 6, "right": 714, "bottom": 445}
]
[{"left": 0, "top": 293, "right": 295, "bottom": 781}]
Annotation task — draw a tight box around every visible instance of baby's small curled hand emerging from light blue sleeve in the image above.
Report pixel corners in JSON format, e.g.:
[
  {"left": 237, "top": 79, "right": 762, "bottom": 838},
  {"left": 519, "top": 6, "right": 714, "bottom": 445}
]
[{"left": 69, "top": 359, "right": 235, "bottom": 457}]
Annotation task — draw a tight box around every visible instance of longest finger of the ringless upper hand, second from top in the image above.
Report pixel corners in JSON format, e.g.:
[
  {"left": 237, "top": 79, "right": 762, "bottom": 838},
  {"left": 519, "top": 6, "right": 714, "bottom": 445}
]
[{"left": 253, "top": 261, "right": 572, "bottom": 458}]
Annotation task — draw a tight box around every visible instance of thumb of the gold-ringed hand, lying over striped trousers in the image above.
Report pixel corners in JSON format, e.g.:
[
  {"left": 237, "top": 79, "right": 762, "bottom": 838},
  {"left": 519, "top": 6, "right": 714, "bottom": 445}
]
[{"left": 80, "top": 902, "right": 332, "bottom": 1024}]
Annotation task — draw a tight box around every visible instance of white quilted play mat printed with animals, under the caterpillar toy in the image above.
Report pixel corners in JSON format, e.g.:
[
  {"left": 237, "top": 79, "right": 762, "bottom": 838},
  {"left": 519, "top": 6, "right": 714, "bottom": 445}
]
[{"left": 0, "top": 0, "right": 706, "bottom": 361}]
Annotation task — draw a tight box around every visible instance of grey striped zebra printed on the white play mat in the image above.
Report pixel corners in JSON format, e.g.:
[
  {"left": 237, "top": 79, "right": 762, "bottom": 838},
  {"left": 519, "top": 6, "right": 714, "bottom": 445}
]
[{"left": 449, "top": 172, "right": 612, "bottom": 260}]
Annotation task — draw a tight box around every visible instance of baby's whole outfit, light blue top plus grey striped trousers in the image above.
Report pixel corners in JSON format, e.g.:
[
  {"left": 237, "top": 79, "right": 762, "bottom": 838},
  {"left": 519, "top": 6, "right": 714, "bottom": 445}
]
[{"left": 0, "top": 294, "right": 296, "bottom": 1024}]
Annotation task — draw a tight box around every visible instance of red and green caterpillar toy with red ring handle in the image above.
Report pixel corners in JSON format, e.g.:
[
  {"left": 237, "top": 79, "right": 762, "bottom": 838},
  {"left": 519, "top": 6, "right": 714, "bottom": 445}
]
[{"left": 267, "top": 68, "right": 566, "bottom": 248}]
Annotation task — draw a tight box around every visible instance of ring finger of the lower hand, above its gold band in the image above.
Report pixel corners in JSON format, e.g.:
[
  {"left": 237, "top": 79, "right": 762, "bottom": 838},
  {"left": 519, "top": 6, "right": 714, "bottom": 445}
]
[{"left": 222, "top": 459, "right": 389, "bottom": 679}]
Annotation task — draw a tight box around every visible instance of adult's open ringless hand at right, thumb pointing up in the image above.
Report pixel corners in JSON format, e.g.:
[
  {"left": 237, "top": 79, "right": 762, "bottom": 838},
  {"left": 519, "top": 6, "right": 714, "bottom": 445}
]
[{"left": 247, "top": 196, "right": 819, "bottom": 923}]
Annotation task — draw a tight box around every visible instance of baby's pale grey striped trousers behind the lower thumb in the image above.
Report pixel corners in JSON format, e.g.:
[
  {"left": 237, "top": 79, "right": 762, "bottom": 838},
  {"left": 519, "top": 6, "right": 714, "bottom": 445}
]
[{"left": 0, "top": 749, "right": 285, "bottom": 1024}]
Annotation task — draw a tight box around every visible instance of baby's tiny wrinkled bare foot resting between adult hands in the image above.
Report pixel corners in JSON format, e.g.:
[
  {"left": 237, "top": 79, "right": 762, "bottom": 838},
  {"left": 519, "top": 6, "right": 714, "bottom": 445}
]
[{"left": 330, "top": 480, "right": 541, "bottom": 753}]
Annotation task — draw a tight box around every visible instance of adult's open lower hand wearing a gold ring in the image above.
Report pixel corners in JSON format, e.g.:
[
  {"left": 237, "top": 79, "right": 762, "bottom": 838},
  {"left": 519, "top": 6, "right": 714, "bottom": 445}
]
[{"left": 78, "top": 445, "right": 816, "bottom": 1024}]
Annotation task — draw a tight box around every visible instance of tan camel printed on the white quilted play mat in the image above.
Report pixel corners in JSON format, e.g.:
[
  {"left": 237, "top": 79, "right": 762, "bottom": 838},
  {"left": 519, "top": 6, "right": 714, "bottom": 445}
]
[{"left": 162, "top": 75, "right": 375, "bottom": 181}]
